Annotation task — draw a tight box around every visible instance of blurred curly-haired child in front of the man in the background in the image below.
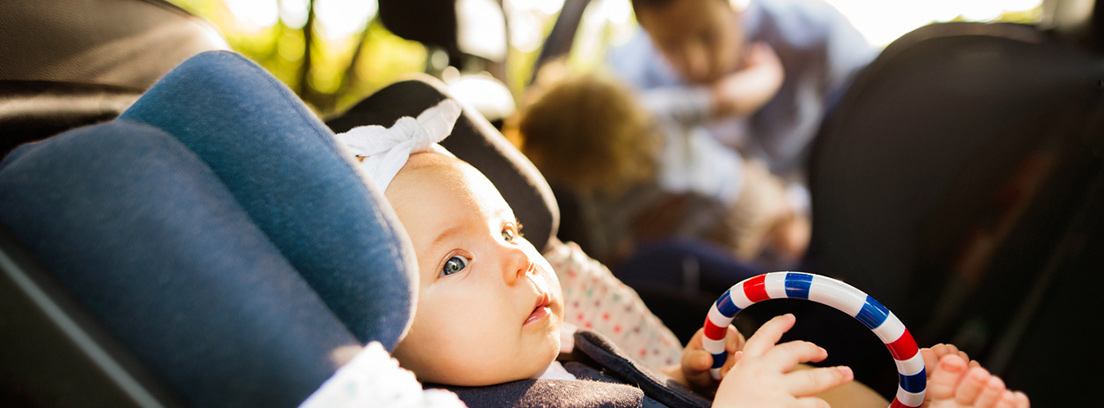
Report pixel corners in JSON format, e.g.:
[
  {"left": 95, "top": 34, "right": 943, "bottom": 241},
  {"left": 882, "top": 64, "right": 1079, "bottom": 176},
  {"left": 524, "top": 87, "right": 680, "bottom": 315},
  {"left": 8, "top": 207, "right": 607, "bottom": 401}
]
[{"left": 518, "top": 70, "right": 809, "bottom": 268}]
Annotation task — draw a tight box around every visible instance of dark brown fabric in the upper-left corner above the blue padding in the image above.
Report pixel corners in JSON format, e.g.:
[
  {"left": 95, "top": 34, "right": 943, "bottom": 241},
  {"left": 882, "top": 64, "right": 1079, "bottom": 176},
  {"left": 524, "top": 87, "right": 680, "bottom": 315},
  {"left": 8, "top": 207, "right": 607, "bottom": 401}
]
[{"left": 0, "top": 0, "right": 229, "bottom": 155}]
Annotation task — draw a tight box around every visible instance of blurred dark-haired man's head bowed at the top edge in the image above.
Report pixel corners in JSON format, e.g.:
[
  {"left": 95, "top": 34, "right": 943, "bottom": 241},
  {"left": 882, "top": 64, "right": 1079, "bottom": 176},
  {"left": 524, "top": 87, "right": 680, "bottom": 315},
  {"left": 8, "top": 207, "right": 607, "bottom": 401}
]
[{"left": 633, "top": 0, "right": 744, "bottom": 84}]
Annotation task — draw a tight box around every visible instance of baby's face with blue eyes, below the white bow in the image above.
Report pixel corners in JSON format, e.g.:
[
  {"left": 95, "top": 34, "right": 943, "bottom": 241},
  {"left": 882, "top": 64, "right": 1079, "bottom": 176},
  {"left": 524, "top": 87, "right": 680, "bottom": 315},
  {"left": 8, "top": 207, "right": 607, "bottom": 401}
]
[{"left": 385, "top": 153, "right": 563, "bottom": 386}]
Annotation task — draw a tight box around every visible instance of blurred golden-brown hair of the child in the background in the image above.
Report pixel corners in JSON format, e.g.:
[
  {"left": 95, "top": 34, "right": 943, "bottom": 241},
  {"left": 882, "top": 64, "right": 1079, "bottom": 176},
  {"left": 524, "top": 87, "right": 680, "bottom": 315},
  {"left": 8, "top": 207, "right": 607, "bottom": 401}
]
[{"left": 518, "top": 73, "right": 662, "bottom": 194}]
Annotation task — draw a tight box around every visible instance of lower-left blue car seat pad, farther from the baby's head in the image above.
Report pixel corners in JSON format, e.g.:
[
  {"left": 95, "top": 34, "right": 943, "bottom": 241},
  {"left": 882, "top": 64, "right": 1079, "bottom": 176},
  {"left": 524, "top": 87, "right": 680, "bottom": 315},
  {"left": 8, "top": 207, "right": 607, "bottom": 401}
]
[{"left": 0, "top": 120, "right": 360, "bottom": 407}]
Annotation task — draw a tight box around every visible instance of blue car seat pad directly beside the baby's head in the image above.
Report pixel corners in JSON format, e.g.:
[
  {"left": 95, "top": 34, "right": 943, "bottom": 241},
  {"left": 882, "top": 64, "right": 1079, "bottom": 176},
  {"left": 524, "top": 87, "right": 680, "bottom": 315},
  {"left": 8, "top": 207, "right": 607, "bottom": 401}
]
[{"left": 120, "top": 51, "right": 417, "bottom": 350}]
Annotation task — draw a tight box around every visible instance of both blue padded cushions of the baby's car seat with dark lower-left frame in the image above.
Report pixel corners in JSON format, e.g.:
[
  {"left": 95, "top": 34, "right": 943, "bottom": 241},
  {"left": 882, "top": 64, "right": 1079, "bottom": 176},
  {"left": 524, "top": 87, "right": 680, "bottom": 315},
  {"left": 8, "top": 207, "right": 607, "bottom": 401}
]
[{"left": 0, "top": 52, "right": 414, "bottom": 406}]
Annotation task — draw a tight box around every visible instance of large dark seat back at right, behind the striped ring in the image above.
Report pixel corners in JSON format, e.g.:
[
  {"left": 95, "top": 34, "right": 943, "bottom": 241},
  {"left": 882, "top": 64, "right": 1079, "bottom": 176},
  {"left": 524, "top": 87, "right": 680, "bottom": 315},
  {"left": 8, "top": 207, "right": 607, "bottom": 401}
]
[{"left": 809, "top": 23, "right": 1104, "bottom": 405}]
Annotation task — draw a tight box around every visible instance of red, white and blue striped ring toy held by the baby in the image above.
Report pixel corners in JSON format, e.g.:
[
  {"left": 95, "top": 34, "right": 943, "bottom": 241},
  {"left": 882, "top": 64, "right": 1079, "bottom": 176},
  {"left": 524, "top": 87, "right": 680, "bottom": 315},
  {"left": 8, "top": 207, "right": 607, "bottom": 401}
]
[{"left": 702, "top": 272, "right": 927, "bottom": 408}]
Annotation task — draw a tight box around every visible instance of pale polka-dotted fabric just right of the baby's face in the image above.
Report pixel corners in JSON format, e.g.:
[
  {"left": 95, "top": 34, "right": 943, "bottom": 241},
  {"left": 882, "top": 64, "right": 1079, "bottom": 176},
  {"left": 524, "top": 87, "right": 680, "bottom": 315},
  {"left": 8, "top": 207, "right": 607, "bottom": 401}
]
[{"left": 544, "top": 243, "right": 682, "bottom": 369}]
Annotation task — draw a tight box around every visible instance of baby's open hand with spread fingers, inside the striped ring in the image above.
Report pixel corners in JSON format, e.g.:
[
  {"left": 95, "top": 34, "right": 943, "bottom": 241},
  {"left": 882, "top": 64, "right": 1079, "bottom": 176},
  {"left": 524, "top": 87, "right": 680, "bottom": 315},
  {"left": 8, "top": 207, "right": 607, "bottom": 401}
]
[{"left": 713, "top": 314, "right": 854, "bottom": 407}]
